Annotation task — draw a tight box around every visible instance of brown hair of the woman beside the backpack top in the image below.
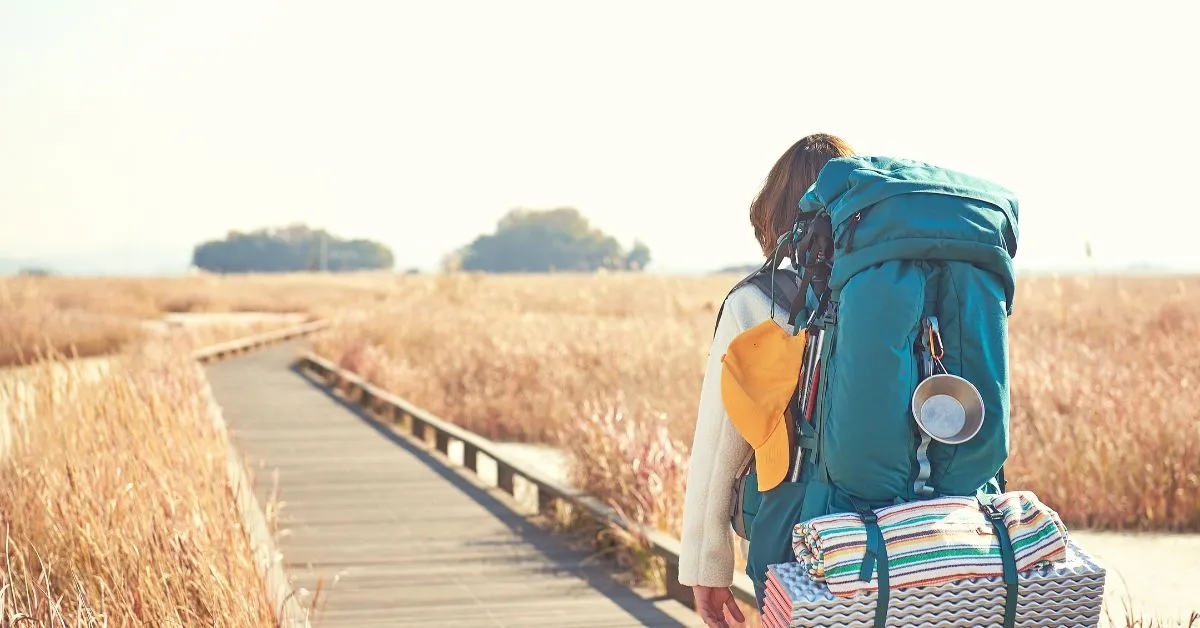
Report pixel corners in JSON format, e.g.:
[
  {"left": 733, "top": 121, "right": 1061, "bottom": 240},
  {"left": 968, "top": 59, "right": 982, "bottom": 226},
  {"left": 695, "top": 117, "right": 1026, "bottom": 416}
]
[{"left": 750, "top": 133, "right": 854, "bottom": 256}]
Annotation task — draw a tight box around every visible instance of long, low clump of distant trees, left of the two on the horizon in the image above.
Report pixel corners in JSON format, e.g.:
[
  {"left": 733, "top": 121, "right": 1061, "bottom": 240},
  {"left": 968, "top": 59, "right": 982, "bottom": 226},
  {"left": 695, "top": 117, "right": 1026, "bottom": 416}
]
[{"left": 192, "top": 225, "right": 395, "bottom": 273}]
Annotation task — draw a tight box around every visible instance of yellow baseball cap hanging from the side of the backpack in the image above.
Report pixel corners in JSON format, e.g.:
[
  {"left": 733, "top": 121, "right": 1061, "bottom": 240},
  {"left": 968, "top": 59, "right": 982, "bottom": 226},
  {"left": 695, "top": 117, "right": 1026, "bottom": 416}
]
[{"left": 721, "top": 318, "right": 805, "bottom": 491}]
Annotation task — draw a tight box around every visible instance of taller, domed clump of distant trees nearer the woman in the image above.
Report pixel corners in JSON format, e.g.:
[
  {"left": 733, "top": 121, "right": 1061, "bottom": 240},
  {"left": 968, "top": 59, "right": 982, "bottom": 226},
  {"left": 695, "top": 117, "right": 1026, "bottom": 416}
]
[{"left": 443, "top": 208, "right": 650, "bottom": 273}]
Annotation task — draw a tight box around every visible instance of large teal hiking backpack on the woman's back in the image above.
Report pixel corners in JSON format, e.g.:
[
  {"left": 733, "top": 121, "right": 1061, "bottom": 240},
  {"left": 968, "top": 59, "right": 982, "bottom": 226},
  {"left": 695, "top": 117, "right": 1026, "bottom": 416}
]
[{"left": 746, "top": 156, "right": 1018, "bottom": 606}]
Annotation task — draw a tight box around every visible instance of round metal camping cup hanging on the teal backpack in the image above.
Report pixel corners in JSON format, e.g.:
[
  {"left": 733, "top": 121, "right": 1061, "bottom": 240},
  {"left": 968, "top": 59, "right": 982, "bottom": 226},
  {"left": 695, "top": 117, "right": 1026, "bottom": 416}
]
[{"left": 912, "top": 373, "right": 984, "bottom": 444}]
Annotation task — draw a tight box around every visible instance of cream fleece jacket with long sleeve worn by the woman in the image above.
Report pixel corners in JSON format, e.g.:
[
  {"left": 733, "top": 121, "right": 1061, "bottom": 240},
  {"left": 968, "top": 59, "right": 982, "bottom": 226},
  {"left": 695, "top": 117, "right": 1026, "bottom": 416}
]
[{"left": 679, "top": 273, "right": 792, "bottom": 587}]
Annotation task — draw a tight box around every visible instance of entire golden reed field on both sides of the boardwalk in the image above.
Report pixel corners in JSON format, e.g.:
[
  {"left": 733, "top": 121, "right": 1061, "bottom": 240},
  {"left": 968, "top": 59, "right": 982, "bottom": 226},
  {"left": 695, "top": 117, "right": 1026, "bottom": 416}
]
[{"left": 0, "top": 273, "right": 1200, "bottom": 626}]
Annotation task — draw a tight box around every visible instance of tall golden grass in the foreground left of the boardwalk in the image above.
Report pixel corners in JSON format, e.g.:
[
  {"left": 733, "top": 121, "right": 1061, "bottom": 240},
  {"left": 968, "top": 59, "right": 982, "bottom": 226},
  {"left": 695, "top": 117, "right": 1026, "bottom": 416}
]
[{"left": 0, "top": 345, "right": 274, "bottom": 627}]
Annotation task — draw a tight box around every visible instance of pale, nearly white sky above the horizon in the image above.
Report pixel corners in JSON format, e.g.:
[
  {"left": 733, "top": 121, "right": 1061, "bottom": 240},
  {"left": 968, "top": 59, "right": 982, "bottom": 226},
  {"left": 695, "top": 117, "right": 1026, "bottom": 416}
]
[{"left": 0, "top": 0, "right": 1200, "bottom": 271}]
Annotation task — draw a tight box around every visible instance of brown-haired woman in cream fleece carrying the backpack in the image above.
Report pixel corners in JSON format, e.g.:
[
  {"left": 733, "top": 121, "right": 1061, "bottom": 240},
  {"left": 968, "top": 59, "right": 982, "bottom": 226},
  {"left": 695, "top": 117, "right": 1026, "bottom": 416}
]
[{"left": 679, "top": 133, "right": 853, "bottom": 627}]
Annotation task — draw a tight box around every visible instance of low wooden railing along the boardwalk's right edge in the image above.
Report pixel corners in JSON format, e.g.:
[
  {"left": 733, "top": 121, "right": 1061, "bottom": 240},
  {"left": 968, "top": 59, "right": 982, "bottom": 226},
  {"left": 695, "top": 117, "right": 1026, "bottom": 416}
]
[{"left": 299, "top": 352, "right": 755, "bottom": 608}]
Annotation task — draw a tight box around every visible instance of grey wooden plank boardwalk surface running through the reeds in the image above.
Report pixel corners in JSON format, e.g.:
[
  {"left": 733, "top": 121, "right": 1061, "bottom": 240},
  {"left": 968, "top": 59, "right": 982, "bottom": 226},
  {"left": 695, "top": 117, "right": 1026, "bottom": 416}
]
[{"left": 201, "top": 345, "right": 702, "bottom": 627}]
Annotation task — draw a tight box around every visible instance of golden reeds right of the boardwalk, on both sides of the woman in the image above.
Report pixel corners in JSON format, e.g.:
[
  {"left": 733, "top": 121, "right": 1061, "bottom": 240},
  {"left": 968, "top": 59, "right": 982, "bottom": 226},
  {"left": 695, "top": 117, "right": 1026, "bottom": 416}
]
[{"left": 316, "top": 275, "right": 1200, "bottom": 534}]
